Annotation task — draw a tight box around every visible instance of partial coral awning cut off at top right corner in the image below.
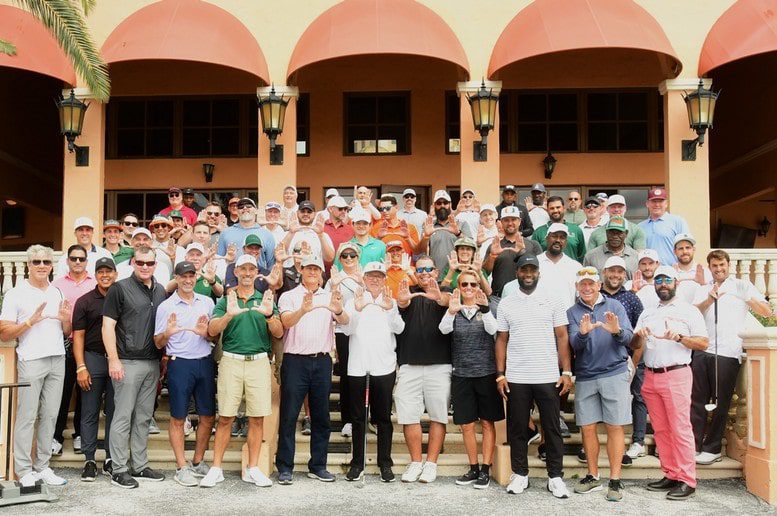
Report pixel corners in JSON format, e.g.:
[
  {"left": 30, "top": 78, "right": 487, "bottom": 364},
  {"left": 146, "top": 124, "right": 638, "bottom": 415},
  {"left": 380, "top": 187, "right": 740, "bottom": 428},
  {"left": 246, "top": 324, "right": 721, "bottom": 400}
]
[{"left": 699, "top": 0, "right": 777, "bottom": 76}]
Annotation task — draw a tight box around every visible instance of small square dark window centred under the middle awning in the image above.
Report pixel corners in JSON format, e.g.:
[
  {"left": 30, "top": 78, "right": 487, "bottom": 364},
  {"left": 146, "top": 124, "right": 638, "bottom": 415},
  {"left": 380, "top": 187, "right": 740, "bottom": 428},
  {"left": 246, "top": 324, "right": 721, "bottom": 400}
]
[{"left": 343, "top": 93, "right": 410, "bottom": 155}]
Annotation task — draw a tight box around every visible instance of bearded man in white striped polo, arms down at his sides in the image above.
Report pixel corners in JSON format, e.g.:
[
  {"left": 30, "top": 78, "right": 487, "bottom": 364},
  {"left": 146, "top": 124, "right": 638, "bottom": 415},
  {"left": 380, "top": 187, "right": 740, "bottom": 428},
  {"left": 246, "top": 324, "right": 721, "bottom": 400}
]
[{"left": 496, "top": 253, "right": 572, "bottom": 498}]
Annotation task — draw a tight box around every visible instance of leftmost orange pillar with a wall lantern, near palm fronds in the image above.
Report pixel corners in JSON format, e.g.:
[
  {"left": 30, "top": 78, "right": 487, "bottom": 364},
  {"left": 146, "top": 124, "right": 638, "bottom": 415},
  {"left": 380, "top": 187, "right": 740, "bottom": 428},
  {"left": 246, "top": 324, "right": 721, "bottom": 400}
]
[{"left": 62, "top": 88, "right": 105, "bottom": 249}]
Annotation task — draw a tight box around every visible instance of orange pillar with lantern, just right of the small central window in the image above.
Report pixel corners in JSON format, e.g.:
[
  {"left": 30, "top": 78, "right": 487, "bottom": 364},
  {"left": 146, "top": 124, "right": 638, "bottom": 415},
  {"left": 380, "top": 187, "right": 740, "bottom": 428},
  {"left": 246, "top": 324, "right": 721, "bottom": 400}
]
[{"left": 457, "top": 81, "right": 502, "bottom": 204}]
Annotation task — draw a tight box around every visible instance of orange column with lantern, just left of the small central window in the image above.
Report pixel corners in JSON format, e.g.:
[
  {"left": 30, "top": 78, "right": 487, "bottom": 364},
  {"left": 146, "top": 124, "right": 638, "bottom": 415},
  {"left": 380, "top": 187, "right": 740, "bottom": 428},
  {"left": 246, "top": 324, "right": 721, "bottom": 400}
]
[{"left": 256, "top": 85, "right": 299, "bottom": 204}]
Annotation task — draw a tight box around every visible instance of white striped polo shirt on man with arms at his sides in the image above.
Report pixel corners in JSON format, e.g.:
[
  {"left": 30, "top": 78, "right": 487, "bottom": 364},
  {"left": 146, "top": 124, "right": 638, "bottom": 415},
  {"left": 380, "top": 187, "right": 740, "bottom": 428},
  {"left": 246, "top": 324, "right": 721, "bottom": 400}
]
[{"left": 496, "top": 290, "right": 568, "bottom": 384}]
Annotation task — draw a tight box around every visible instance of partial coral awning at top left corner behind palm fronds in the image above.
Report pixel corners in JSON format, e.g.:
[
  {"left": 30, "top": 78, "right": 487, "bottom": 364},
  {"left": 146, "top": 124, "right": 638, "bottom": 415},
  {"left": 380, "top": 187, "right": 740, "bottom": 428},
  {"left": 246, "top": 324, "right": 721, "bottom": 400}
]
[{"left": 0, "top": 5, "right": 76, "bottom": 86}]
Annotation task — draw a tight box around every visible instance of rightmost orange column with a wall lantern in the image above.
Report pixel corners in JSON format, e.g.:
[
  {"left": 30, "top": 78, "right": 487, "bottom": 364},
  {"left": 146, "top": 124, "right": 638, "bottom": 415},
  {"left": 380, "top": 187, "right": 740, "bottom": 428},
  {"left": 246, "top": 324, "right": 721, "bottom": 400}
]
[{"left": 658, "top": 77, "right": 712, "bottom": 255}]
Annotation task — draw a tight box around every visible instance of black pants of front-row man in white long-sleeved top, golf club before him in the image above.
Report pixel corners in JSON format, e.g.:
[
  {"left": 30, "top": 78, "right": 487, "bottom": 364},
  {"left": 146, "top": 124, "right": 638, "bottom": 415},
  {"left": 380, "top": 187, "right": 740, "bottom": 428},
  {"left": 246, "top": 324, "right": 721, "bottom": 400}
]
[{"left": 348, "top": 373, "right": 397, "bottom": 468}]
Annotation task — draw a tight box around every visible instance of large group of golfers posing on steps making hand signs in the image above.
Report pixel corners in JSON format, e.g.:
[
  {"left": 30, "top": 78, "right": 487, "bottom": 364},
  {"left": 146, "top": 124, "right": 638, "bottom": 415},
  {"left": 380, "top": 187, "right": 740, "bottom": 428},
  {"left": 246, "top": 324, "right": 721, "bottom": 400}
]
[{"left": 0, "top": 184, "right": 771, "bottom": 501}]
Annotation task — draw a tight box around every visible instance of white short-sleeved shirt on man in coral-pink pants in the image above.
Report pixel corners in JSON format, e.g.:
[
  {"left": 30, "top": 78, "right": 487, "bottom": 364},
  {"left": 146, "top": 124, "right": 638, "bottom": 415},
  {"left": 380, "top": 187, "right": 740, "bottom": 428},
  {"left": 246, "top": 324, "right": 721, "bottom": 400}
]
[{"left": 634, "top": 297, "right": 707, "bottom": 368}]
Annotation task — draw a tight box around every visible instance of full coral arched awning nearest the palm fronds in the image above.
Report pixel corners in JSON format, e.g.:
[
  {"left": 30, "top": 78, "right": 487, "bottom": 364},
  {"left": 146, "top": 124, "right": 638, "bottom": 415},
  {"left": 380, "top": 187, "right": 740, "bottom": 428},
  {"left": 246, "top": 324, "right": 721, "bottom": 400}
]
[{"left": 102, "top": 0, "right": 270, "bottom": 84}]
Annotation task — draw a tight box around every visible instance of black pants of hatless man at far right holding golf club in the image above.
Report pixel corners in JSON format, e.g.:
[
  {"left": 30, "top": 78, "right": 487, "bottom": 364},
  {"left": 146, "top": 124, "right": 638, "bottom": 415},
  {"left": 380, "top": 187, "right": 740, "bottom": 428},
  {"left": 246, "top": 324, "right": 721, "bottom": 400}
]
[{"left": 691, "top": 351, "right": 740, "bottom": 453}]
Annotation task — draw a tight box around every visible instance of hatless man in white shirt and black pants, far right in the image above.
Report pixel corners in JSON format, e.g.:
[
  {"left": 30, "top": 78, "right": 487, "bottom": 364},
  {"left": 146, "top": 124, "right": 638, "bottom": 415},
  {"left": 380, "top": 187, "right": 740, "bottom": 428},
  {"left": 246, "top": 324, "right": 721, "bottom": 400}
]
[{"left": 691, "top": 250, "right": 772, "bottom": 464}]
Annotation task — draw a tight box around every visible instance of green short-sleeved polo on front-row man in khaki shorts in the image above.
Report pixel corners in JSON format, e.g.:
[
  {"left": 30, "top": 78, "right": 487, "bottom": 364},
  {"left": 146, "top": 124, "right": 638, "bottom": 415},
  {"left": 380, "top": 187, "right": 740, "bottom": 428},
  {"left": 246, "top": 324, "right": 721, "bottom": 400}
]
[{"left": 213, "top": 290, "right": 278, "bottom": 355}]
